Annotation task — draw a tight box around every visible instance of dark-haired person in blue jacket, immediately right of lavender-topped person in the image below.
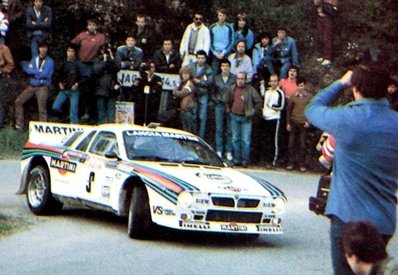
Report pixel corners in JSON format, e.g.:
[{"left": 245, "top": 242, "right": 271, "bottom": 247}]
[{"left": 252, "top": 33, "right": 273, "bottom": 81}]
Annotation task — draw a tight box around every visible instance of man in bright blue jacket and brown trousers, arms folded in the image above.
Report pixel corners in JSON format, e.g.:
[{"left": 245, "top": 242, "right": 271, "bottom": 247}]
[{"left": 15, "top": 41, "right": 54, "bottom": 130}]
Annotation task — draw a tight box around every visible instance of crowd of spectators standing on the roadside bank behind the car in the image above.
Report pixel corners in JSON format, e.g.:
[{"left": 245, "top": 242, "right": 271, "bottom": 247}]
[{"left": 0, "top": 0, "right": 397, "bottom": 172}]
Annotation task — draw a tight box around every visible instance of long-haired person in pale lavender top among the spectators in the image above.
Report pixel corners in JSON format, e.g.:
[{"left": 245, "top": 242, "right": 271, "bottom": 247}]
[{"left": 228, "top": 41, "right": 253, "bottom": 83}]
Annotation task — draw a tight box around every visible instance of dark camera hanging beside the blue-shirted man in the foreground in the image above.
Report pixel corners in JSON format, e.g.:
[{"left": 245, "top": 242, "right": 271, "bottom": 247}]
[{"left": 308, "top": 174, "right": 331, "bottom": 215}]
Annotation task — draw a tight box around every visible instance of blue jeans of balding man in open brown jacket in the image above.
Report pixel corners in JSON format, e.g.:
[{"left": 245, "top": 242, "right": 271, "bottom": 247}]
[{"left": 230, "top": 113, "right": 252, "bottom": 164}]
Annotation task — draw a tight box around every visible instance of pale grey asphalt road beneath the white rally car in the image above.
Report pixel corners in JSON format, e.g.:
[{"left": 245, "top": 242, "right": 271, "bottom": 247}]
[{"left": 0, "top": 160, "right": 398, "bottom": 274}]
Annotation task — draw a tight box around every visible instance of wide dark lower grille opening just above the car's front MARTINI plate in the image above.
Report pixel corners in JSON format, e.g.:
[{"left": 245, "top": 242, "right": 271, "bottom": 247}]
[{"left": 206, "top": 210, "right": 262, "bottom": 223}]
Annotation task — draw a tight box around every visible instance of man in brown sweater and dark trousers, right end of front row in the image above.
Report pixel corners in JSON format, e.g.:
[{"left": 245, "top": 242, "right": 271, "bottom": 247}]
[{"left": 286, "top": 78, "right": 312, "bottom": 172}]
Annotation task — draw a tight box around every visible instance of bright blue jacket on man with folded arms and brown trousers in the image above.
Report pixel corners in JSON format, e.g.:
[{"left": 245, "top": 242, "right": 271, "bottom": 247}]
[{"left": 22, "top": 56, "right": 54, "bottom": 87}]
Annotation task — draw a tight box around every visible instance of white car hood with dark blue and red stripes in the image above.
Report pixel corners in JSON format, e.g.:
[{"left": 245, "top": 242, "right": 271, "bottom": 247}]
[{"left": 131, "top": 162, "right": 284, "bottom": 197}]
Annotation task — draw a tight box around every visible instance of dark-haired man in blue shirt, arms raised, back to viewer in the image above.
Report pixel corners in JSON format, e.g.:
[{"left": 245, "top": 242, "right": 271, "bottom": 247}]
[{"left": 305, "top": 65, "right": 398, "bottom": 274}]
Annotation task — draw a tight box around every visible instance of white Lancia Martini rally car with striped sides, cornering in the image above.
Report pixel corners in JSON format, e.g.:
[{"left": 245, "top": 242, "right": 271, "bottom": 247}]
[{"left": 18, "top": 122, "right": 286, "bottom": 238}]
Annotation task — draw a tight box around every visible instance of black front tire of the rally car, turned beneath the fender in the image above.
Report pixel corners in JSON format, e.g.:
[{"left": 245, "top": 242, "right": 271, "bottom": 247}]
[{"left": 127, "top": 185, "right": 154, "bottom": 239}]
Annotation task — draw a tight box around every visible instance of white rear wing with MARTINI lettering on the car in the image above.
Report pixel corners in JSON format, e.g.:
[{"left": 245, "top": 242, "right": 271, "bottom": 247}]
[{"left": 28, "top": 121, "right": 94, "bottom": 145}]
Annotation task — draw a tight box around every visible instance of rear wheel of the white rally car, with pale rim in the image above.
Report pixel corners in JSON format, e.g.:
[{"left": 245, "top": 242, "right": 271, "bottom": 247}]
[{"left": 26, "top": 165, "right": 62, "bottom": 215}]
